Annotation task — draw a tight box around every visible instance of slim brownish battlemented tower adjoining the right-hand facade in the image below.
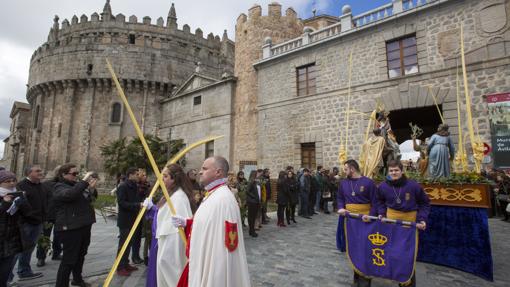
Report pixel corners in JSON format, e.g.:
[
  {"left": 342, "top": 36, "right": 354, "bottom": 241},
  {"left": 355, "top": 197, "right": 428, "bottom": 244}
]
[{"left": 232, "top": 2, "right": 303, "bottom": 169}]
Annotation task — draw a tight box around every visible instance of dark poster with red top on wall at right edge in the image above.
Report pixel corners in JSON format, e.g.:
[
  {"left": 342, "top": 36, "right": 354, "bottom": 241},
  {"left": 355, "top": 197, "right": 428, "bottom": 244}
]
[{"left": 486, "top": 93, "right": 510, "bottom": 169}]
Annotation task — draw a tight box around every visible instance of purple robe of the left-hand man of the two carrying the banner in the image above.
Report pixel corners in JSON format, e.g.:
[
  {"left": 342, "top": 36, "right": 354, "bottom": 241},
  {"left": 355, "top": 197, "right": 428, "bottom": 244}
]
[{"left": 337, "top": 176, "right": 377, "bottom": 216}]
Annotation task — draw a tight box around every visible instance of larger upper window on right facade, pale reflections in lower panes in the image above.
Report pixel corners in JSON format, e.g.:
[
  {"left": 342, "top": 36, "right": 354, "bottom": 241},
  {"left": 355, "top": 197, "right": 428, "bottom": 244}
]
[{"left": 386, "top": 35, "right": 418, "bottom": 78}]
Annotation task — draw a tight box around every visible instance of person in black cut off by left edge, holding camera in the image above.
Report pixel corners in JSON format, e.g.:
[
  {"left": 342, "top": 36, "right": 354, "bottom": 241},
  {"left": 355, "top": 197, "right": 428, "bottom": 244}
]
[{"left": 0, "top": 170, "right": 30, "bottom": 287}]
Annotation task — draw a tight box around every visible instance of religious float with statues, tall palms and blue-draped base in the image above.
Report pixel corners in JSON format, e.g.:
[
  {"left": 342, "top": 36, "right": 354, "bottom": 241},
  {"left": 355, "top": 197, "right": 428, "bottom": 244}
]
[{"left": 337, "top": 26, "right": 493, "bottom": 281}]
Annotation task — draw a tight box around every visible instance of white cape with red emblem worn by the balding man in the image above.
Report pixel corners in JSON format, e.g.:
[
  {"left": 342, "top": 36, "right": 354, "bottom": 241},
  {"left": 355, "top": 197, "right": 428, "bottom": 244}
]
[{"left": 189, "top": 185, "right": 250, "bottom": 287}]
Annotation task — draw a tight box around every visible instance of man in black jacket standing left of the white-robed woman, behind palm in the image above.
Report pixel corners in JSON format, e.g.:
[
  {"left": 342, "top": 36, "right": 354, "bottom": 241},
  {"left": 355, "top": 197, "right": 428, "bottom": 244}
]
[{"left": 117, "top": 168, "right": 143, "bottom": 276}]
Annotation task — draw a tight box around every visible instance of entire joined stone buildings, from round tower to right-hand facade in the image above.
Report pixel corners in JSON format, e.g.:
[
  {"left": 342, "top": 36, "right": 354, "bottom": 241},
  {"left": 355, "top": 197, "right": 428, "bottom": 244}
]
[{"left": 1, "top": 0, "right": 510, "bottom": 178}]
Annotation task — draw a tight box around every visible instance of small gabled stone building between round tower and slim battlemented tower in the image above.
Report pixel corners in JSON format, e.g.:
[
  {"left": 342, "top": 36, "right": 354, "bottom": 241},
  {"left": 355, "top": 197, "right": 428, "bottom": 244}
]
[{"left": 159, "top": 69, "right": 236, "bottom": 168}]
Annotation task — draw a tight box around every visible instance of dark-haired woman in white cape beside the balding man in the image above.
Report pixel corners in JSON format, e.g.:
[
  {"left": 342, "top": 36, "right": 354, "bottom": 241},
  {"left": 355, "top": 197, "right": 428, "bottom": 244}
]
[{"left": 156, "top": 164, "right": 195, "bottom": 286}]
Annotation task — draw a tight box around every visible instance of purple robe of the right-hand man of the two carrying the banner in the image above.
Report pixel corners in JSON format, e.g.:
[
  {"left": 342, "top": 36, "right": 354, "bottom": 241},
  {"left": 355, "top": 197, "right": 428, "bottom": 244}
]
[{"left": 377, "top": 179, "right": 430, "bottom": 222}]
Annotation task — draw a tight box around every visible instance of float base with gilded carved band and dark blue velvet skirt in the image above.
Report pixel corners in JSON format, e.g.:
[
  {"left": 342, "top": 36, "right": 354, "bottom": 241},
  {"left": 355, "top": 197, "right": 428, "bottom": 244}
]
[{"left": 390, "top": 173, "right": 493, "bottom": 281}]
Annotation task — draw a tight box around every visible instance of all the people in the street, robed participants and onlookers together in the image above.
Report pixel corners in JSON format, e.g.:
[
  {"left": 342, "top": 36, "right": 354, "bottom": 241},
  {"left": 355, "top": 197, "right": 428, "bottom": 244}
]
[{"left": 0, "top": 157, "right": 510, "bottom": 287}]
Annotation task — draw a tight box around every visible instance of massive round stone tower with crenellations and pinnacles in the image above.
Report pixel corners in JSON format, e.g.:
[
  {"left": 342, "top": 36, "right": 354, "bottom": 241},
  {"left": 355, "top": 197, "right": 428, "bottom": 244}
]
[{"left": 25, "top": 0, "right": 234, "bottom": 171}]
